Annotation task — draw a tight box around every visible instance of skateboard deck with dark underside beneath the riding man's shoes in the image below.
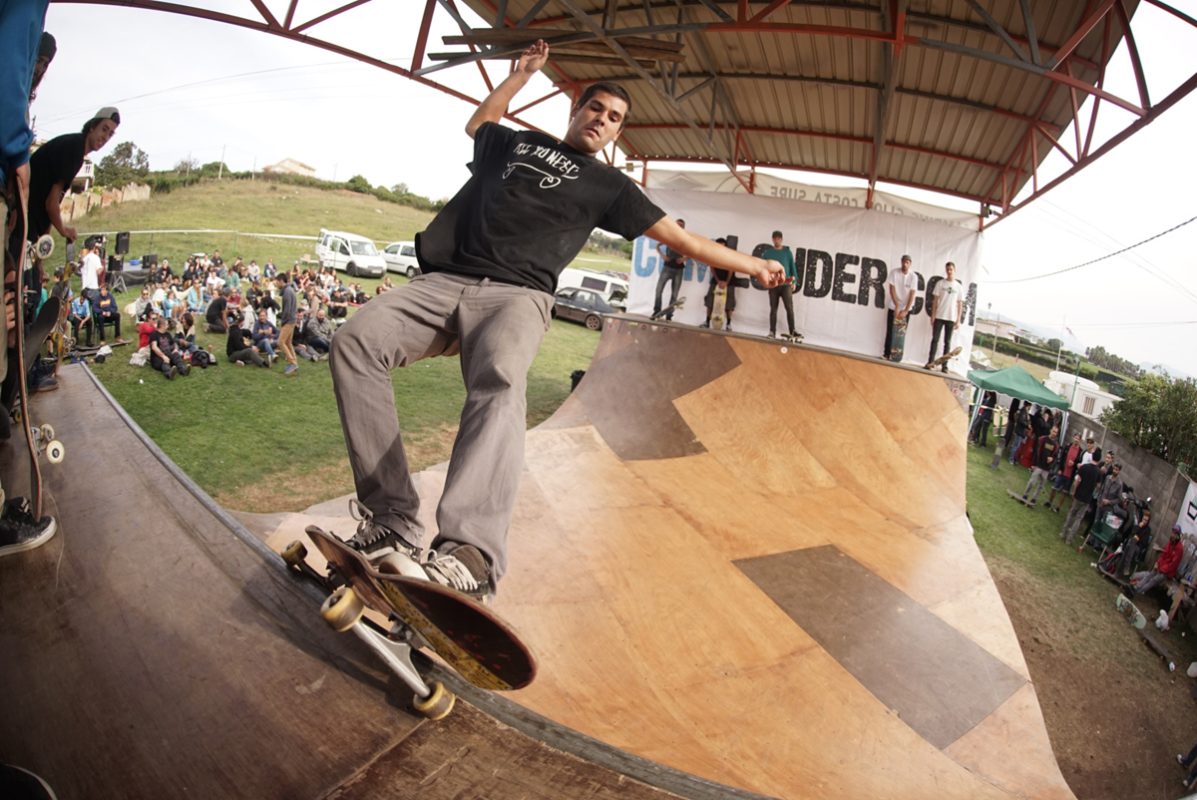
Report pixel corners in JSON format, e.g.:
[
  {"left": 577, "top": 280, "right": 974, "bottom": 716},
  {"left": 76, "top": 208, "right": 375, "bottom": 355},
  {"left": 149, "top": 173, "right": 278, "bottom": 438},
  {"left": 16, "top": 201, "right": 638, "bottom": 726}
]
[{"left": 284, "top": 526, "right": 536, "bottom": 710}]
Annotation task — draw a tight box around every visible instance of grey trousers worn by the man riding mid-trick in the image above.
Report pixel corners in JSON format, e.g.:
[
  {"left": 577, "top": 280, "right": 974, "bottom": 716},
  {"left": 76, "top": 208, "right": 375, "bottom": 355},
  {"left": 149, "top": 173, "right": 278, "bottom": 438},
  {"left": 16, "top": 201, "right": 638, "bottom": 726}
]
[{"left": 329, "top": 272, "right": 553, "bottom": 580}]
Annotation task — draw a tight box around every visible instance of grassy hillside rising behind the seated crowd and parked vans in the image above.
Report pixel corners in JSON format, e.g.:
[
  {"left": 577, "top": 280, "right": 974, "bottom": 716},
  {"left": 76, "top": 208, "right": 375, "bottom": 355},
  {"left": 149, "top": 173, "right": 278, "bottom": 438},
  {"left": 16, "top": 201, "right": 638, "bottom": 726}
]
[{"left": 54, "top": 180, "right": 432, "bottom": 265}]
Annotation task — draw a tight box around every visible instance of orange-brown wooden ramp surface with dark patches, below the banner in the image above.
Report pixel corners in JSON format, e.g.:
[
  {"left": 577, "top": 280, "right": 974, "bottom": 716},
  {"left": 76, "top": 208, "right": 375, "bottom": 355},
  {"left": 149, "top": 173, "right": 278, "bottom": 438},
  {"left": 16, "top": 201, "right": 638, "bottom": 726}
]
[{"left": 266, "top": 319, "right": 1073, "bottom": 800}]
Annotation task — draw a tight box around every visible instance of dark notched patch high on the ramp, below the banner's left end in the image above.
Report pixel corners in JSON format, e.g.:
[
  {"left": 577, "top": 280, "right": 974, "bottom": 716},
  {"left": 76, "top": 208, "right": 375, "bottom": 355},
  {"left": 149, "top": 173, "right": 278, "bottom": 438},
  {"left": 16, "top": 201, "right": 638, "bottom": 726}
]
[{"left": 573, "top": 323, "right": 740, "bottom": 461}]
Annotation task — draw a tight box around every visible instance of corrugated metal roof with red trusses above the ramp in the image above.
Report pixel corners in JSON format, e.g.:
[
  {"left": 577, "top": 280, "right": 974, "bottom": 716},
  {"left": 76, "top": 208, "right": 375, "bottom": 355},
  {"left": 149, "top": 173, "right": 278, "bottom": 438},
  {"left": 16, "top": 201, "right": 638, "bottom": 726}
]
[{"left": 69, "top": 0, "right": 1197, "bottom": 225}]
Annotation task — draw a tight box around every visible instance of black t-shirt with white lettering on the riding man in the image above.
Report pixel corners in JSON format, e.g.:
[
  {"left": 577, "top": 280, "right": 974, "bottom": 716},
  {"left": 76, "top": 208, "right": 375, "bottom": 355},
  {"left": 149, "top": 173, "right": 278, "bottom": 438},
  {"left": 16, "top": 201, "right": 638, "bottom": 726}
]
[{"left": 415, "top": 122, "right": 666, "bottom": 293}]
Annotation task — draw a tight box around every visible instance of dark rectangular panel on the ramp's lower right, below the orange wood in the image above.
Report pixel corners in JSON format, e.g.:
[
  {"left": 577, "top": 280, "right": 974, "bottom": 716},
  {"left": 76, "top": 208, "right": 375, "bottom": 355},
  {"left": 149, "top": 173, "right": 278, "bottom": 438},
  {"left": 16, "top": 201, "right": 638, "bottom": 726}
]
[{"left": 736, "top": 545, "right": 1026, "bottom": 750}]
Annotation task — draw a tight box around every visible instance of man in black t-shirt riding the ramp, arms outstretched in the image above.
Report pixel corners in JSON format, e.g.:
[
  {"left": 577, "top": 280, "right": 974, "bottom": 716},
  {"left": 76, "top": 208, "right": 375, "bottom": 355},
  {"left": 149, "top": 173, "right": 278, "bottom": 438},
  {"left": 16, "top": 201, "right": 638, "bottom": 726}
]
[{"left": 329, "top": 41, "right": 782, "bottom": 599}]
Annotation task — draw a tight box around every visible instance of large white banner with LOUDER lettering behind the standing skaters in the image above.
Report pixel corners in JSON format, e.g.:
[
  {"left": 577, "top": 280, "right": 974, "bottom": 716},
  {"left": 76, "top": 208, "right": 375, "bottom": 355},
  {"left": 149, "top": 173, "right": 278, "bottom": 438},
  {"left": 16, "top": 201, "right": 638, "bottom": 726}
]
[{"left": 627, "top": 189, "right": 982, "bottom": 374}]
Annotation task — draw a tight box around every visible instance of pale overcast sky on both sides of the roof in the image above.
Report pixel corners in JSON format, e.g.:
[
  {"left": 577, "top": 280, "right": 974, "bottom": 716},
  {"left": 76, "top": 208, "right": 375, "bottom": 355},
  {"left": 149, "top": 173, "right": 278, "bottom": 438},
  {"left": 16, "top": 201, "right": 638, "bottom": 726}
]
[{"left": 34, "top": 0, "right": 1197, "bottom": 376}]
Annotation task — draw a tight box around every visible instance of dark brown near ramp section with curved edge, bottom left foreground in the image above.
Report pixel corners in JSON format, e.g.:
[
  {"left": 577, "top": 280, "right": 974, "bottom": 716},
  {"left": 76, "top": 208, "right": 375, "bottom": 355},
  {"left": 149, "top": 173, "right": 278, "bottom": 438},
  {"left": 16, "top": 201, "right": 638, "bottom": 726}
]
[{"left": 0, "top": 365, "right": 775, "bottom": 800}]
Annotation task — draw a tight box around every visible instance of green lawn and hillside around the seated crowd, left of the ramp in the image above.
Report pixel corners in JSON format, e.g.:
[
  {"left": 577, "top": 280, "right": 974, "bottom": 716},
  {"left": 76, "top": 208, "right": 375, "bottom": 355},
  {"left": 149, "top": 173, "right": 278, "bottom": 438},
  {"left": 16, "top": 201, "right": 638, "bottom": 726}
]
[{"left": 78, "top": 181, "right": 608, "bottom": 510}]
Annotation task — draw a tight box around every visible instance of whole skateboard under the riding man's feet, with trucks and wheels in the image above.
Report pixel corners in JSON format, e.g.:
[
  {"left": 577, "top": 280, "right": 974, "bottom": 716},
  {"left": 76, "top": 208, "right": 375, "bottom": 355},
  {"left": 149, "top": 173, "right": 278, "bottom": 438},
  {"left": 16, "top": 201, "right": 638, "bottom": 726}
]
[{"left": 282, "top": 526, "right": 536, "bottom": 720}]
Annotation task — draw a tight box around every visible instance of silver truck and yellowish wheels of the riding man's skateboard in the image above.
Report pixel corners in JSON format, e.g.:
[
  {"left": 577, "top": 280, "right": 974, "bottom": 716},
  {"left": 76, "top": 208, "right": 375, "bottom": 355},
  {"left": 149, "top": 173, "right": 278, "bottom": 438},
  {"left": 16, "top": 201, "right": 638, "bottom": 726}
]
[{"left": 282, "top": 541, "right": 457, "bottom": 720}]
